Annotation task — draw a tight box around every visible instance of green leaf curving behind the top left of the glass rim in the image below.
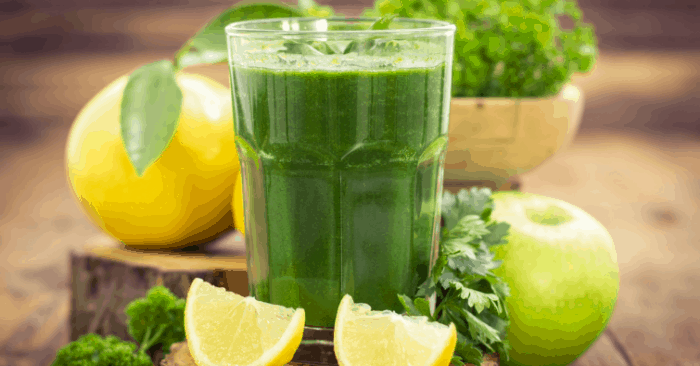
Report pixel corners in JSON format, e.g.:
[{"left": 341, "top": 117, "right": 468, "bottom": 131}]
[{"left": 175, "top": 3, "right": 303, "bottom": 69}]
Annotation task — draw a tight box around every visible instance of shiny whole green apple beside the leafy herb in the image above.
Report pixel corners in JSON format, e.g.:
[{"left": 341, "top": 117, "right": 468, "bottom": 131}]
[{"left": 492, "top": 191, "right": 620, "bottom": 366}]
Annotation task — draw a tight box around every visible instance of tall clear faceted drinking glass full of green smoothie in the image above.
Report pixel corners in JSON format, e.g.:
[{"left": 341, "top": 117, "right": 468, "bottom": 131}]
[{"left": 226, "top": 18, "right": 455, "bottom": 364}]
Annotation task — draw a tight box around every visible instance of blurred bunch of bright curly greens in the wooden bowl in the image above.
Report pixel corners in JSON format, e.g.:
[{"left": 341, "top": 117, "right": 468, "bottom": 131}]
[{"left": 363, "top": 0, "right": 598, "bottom": 98}]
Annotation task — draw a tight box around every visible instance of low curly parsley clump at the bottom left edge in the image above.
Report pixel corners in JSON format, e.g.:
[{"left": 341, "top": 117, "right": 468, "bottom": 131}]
[{"left": 51, "top": 333, "right": 153, "bottom": 366}]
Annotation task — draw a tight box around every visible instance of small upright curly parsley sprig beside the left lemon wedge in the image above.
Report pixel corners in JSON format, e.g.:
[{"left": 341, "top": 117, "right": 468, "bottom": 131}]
[{"left": 124, "top": 286, "right": 185, "bottom": 354}]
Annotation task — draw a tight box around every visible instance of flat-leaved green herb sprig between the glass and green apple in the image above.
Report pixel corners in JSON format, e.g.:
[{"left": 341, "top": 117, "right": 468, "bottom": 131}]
[{"left": 399, "top": 188, "right": 510, "bottom": 366}]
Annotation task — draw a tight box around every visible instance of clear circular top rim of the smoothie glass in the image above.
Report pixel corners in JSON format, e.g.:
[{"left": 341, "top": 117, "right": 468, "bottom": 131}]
[{"left": 225, "top": 17, "right": 457, "bottom": 37}]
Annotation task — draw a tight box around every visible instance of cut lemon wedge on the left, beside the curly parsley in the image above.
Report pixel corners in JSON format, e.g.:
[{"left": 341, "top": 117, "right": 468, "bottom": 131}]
[{"left": 185, "top": 278, "right": 304, "bottom": 366}]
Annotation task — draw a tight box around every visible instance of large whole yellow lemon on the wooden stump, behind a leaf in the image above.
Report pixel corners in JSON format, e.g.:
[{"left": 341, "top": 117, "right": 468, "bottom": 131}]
[{"left": 66, "top": 73, "right": 240, "bottom": 249}]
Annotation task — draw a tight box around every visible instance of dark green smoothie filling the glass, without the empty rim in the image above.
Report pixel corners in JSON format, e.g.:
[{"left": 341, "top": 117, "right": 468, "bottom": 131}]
[{"left": 231, "top": 61, "right": 449, "bottom": 327}]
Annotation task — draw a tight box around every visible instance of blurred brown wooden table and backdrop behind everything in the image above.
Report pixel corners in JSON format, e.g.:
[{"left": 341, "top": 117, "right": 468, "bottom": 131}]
[{"left": 0, "top": 0, "right": 700, "bottom": 366}]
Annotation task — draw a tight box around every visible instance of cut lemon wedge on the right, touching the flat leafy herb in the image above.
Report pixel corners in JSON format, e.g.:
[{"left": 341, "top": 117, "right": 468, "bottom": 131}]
[{"left": 334, "top": 295, "right": 457, "bottom": 366}]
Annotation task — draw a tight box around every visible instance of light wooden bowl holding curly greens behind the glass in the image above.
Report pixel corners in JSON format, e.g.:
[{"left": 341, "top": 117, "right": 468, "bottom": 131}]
[{"left": 444, "top": 84, "right": 584, "bottom": 187}]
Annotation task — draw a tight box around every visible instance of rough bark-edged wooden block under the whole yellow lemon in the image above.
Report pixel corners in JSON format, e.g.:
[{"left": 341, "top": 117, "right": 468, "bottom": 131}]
[{"left": 70, "top": 231, "right": 248, "bottom": 362}]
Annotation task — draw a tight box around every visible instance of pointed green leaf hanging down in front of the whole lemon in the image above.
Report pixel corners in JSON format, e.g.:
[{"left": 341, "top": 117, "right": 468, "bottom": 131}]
[{"left": 120, "top": 60, "right": 182, "bottom": 176}]
